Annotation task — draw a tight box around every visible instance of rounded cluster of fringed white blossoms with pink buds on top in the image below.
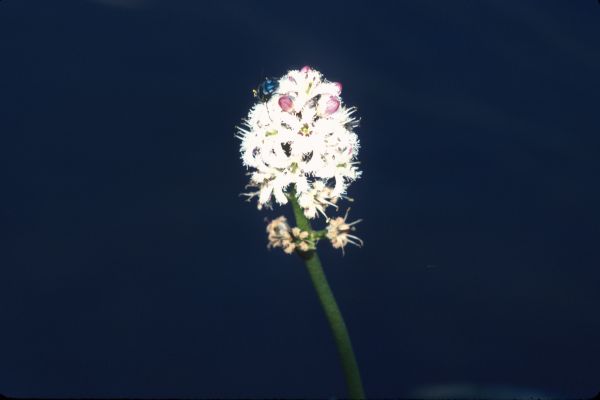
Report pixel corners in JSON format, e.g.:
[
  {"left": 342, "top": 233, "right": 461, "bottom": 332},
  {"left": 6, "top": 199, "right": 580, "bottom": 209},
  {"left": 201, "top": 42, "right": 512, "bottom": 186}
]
[{"left": 237, "top": 67, "right": 360, "bottom": 218}]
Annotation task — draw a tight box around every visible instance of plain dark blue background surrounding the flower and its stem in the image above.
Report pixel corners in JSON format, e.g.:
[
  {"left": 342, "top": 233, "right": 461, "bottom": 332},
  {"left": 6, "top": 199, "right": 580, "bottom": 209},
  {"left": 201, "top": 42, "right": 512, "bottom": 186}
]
[{"left": 0, "top": 0, "right": 600, "bottom": 397}]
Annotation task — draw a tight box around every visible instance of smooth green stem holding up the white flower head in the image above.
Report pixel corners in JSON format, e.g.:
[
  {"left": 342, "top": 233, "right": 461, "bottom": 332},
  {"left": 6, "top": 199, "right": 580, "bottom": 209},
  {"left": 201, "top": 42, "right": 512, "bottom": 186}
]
[{"left": 289, "top": 191, "right": 365, "bottom": 399}]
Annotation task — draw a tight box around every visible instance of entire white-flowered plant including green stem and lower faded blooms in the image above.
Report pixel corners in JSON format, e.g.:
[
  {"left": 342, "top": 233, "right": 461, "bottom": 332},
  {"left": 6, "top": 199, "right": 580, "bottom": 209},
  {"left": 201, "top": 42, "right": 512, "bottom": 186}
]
[{"left": 236, "top": 67, "right": 365, "bottom": 399}]
